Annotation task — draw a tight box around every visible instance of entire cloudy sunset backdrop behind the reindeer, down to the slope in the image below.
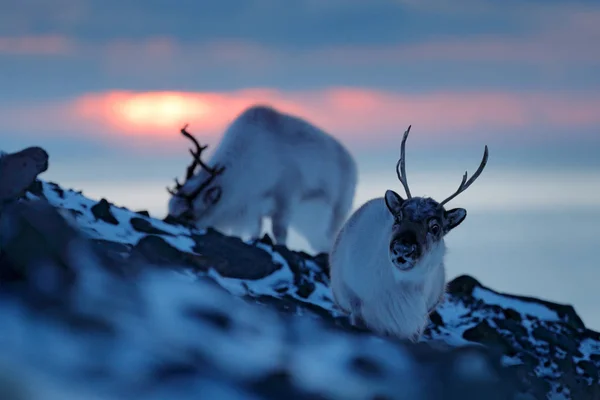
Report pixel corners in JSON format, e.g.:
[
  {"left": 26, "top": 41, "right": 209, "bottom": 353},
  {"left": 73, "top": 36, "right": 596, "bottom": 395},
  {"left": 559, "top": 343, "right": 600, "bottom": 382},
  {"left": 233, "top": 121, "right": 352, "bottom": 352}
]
[{"left": 0, "top": 0, "right": 600, "bottom": 329}]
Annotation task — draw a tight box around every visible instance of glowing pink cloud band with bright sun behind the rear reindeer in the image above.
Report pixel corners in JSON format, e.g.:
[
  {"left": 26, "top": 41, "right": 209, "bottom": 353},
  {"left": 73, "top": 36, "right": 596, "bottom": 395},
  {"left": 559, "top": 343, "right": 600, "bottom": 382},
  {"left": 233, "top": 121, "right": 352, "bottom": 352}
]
[{"left": 0, "top": 87, "right": 600, "bottom": 152}]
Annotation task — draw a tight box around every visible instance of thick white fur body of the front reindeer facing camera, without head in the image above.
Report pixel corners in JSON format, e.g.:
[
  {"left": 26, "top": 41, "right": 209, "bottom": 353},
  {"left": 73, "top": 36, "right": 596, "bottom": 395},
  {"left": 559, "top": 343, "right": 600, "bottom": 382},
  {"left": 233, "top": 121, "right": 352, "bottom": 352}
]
[{"left": 330, "top": 197, "right": 446, "bottom": 340}]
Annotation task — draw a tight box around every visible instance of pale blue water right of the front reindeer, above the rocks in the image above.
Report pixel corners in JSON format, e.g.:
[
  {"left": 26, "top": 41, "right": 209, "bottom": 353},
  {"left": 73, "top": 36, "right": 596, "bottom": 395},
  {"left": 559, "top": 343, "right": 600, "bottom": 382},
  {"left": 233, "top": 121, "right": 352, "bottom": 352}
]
[{"left": 447, "top": 207, "right": 600, "bottom": 330}]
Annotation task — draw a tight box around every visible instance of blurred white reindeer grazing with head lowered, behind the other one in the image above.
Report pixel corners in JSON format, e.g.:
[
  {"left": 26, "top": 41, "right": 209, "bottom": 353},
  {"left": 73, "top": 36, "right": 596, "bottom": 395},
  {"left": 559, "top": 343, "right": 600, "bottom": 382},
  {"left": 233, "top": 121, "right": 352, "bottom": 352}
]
[{"left": 167, "top": 105, "right": 357, "bottom": 252}]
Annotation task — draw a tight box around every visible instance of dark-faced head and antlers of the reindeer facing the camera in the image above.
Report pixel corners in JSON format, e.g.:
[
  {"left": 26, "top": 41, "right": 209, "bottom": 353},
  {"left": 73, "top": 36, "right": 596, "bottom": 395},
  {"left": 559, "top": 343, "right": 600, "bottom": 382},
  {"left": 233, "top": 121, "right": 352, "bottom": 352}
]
[{"left": 385, "top": 126, "right": 488, "bottom": 271}]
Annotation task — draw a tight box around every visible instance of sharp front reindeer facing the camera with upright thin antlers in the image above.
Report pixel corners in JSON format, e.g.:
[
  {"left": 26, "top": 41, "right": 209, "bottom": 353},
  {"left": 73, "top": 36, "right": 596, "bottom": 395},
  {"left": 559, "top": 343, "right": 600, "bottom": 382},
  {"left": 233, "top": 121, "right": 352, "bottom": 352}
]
[{"left": 329, "top": 126, "right": 488, "bottom": 340}]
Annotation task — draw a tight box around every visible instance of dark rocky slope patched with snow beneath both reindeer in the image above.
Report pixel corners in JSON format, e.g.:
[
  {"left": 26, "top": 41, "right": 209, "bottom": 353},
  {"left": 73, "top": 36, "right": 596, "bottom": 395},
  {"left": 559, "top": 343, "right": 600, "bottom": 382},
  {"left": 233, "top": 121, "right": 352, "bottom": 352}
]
[{"left": 0, "top": 170, "right": 600, "bottom": 400}]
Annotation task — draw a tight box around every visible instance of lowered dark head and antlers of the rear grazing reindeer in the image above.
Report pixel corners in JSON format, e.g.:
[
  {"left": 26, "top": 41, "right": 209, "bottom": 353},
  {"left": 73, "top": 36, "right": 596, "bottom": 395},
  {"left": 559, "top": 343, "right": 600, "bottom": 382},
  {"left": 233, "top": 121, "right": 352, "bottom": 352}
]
[{"left": 166, "top": 125, "right": 225, "bottom": 223}]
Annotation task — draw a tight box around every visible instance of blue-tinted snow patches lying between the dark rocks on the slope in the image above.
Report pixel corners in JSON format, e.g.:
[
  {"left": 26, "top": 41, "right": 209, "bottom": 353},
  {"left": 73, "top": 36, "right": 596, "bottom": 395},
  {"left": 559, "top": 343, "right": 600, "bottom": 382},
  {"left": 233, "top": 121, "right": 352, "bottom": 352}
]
[{"left": 0, "top": 182, "right": 600, "bottom": 400}]
